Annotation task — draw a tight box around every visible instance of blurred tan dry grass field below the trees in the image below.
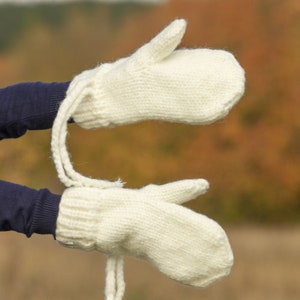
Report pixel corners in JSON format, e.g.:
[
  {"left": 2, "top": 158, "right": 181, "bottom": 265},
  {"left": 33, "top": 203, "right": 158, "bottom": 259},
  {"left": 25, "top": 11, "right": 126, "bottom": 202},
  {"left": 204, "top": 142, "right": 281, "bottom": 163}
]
[{"left": 0, "top": 227, "right": 300, "bottom": 300}]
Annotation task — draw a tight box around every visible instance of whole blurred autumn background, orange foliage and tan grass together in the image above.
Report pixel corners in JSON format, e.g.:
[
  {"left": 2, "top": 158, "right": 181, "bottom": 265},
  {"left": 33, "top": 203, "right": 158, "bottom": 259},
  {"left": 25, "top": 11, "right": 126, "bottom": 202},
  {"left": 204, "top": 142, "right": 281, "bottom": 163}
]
[{"left": 0, "top": 0, "right": 300, "bottom": 300}]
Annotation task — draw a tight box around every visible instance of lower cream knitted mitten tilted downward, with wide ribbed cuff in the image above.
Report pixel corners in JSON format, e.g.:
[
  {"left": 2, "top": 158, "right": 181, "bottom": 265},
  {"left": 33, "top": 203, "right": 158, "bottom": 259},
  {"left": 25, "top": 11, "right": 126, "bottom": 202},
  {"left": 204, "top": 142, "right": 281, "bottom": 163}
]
[{"left": 56, "top": 179, "right": 233, "bottom": 287}]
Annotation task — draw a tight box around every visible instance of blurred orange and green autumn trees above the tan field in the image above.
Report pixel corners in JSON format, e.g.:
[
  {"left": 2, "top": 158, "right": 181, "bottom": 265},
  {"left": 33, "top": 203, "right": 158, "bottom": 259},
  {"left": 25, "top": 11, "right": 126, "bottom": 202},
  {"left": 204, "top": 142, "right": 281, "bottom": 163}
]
[{"left": 0, "top": 0, "right": 300, "bottom": 224}]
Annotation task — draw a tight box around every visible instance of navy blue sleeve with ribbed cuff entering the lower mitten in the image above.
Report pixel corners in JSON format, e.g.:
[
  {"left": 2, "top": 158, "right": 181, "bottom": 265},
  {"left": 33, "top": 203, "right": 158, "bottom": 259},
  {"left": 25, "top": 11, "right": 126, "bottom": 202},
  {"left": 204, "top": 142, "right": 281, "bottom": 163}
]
[{"left": 0, "top": 180, "right": 61, "bottom": 237}]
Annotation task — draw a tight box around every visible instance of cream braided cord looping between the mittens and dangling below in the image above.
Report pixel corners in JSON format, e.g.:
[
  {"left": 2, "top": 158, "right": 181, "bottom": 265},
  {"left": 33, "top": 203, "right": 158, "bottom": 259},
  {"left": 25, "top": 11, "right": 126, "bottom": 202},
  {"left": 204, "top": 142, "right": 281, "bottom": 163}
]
[{"left": 51, "top": 76, "right": 125, "bottom": 300}]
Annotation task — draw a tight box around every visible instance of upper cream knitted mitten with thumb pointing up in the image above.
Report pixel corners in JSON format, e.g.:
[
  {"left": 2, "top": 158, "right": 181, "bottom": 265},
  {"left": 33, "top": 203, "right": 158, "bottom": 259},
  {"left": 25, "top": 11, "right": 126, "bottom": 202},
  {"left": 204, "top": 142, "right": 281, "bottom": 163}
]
[{"left": 67, "top": 20, "right": 245, "bottom": 129}]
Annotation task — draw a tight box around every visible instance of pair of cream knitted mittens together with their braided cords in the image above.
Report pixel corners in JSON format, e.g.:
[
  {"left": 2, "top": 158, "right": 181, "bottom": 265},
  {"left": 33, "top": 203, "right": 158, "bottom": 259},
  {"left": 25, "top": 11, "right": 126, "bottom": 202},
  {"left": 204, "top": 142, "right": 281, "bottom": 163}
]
[{"left": 51, "top": 20, "right": 245, "bottom": 300}]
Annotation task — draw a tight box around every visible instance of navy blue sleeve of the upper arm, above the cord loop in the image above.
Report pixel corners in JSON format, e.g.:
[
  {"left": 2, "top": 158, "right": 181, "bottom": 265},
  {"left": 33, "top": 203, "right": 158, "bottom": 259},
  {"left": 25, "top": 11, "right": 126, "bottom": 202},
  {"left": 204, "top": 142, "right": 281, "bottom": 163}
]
[{"left": 0, "top": 82, "right": 70, "bottom": 140}]
